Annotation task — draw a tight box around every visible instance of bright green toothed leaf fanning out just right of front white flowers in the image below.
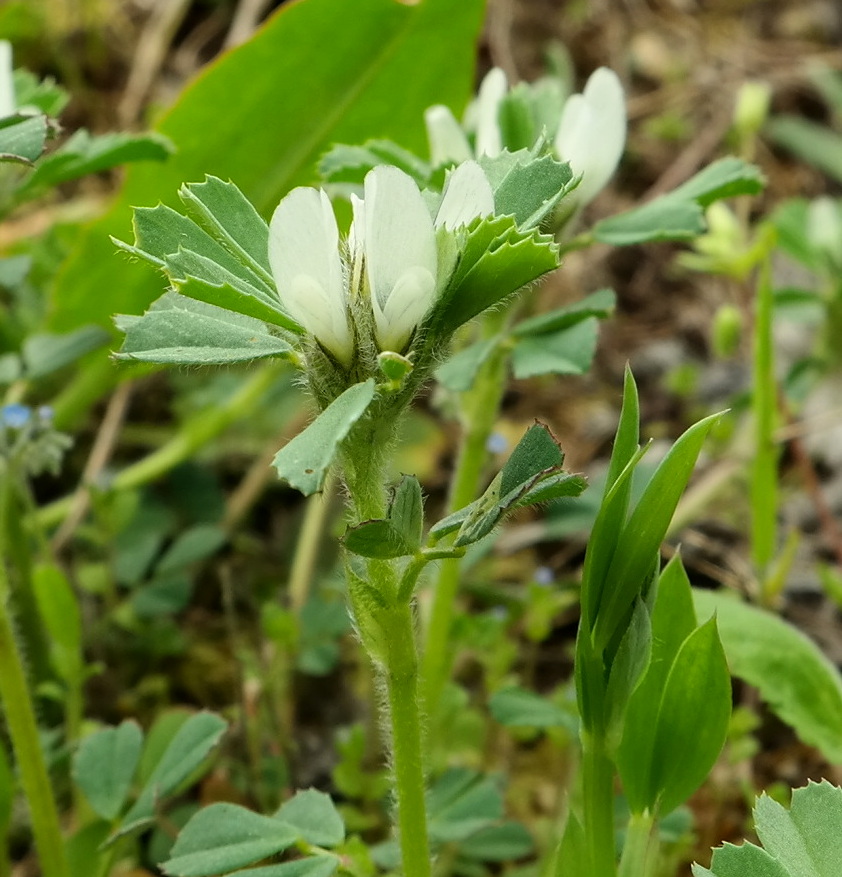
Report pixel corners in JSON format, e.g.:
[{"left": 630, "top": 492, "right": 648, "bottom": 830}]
[{"left": 428, "top": 216, "right": 558, "bottom": 336}]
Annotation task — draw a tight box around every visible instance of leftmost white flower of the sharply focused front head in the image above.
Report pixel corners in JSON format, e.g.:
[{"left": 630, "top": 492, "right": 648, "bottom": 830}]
[{"left": 269, "top": 187, "right": 353, "bottom": 365}]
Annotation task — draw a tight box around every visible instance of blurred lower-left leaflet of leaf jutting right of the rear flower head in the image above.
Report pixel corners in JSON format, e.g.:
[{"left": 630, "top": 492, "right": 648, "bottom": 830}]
[{"left": 592, "top": 194, "right": 706, "bottom": 247}]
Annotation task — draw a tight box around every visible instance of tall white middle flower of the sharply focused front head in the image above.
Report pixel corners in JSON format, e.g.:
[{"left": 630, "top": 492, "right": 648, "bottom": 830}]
[{"left": 364, "top": 166, "right": 438, "bottom": 353}]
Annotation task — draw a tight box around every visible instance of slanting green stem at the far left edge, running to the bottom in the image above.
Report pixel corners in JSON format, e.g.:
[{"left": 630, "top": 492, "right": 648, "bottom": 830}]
[{"left": 0, "top": 486, "right": 70, "bottom": 877}]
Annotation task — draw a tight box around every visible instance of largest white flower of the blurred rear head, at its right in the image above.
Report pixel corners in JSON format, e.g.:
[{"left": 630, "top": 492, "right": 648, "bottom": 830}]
[{"left": 555, "top": 67, "right": 626, "bottom": 205}]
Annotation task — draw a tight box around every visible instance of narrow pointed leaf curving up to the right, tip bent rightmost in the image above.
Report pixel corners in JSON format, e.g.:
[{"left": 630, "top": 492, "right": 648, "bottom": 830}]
[{"left": 593, "top": 414, "right": 720, "bottom": 648}]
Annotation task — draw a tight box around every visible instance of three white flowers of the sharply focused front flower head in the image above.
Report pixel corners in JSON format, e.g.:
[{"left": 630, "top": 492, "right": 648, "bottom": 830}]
[{"left": 269, "top": 161, "right": 494, "bottom": 367}]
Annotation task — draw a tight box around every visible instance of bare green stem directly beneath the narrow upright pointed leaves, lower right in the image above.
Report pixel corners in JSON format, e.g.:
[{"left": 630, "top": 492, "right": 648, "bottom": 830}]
[{"left": 582, "top": 735, "right": 617, "bottom": 877}]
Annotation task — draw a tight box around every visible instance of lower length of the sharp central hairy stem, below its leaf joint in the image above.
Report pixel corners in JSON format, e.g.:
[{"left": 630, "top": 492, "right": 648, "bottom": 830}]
[{"left": 385, "top": 605, "right": 431, "bottom": 877}]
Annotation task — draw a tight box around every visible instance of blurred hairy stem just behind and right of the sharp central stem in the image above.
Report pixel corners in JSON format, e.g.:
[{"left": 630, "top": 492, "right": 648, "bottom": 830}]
[{"left": 421, "top": 311, "right": 507, "bottom": 715}]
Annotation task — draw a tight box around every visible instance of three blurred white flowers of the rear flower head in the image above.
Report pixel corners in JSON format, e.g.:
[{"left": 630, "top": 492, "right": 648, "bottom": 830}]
[{"left": 425, "top": 67, "right": 626, "bottom": 207}]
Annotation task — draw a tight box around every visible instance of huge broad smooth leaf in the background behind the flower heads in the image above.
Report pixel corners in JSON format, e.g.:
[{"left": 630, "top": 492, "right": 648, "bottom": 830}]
[{"left": 51, "top": 0, "right": 484, "bottom": 330}]
